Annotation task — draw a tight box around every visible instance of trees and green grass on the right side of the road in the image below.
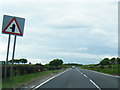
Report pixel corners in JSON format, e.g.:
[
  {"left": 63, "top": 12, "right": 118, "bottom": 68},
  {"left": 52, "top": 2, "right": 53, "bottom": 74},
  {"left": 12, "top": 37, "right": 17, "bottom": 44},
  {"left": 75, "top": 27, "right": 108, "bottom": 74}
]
[{"left": 81, "top": 57, "right": 120, "bottom": 75}]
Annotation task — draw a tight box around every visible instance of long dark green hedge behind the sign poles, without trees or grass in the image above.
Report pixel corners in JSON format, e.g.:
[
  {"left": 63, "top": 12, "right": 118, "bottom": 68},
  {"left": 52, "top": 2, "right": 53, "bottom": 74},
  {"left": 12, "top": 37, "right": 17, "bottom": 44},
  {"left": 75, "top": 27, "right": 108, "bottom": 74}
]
[{"left": 2, "top": 65, "right": 46, "bottom": 79}]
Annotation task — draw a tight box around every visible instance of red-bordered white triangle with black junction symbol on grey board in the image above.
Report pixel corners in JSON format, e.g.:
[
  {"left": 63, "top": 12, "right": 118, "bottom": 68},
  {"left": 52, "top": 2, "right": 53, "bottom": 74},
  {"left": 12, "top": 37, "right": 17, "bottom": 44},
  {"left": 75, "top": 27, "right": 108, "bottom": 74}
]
[{"left": 3, "top": 18, "right": 22, "bottom": 35}]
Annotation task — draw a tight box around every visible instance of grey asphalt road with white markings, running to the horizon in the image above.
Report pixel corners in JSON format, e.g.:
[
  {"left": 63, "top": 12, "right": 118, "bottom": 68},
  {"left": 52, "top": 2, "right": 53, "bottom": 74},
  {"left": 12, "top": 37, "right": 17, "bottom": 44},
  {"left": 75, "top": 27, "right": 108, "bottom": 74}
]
[{"left": 35, "top": 68, "right": 119, "bottom": 90}]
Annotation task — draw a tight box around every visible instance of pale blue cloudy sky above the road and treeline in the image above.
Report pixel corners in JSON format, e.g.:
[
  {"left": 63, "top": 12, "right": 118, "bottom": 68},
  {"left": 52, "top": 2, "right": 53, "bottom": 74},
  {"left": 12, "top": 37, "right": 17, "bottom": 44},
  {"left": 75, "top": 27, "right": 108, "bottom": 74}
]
[{"left": 0, "top": 0, "right": 118, "bottom": 64}]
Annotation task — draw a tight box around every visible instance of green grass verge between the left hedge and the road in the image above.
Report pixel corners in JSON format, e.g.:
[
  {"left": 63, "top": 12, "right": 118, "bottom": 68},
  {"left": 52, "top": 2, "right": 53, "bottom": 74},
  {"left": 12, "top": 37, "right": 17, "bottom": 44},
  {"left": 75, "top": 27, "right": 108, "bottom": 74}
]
[{"left": 2, "top": 70, "right": 63, "bottom": 88}]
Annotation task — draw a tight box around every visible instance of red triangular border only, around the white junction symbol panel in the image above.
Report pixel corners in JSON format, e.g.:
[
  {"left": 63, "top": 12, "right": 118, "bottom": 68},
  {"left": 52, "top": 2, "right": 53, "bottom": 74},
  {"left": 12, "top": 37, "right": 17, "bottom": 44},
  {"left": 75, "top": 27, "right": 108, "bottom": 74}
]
[{"left": 3, "top": 18, "right": 23, "bottom": 36}]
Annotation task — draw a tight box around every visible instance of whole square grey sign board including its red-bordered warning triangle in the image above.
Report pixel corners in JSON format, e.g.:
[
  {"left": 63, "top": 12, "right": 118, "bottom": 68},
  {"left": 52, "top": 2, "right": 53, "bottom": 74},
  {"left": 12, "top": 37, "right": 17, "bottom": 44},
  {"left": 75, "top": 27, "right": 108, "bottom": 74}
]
[{"left": 2, "top": 15, "right": 25, "bottom": 36}]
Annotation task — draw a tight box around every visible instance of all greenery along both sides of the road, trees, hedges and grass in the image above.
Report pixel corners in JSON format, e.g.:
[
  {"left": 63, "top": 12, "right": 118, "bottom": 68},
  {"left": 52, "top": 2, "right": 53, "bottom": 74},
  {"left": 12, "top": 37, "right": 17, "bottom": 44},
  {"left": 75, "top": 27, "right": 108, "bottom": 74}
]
[{"left": 1, "top": 57, "right": 120, "bottom": 88}]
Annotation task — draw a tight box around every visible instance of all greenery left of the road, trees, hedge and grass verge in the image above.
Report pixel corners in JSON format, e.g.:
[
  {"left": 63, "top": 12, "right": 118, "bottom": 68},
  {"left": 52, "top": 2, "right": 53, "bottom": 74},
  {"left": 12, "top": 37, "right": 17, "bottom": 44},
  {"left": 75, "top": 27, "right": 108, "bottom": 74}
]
[{"left": 2, "top": 59, "right": 67, "bottom": 88}]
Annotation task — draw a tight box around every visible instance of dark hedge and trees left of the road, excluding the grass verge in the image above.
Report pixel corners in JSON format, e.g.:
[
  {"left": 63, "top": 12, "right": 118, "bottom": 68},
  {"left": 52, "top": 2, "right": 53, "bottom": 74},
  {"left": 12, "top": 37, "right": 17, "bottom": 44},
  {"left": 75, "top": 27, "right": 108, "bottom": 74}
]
[{"left": 2, "top": 58, "right": 64, "bottom": 79}]
